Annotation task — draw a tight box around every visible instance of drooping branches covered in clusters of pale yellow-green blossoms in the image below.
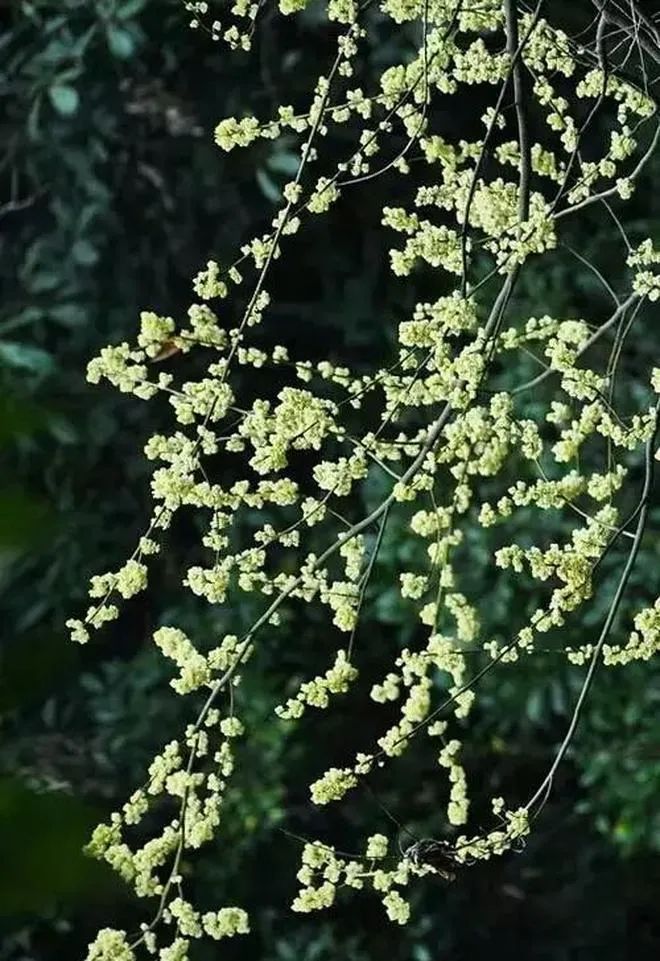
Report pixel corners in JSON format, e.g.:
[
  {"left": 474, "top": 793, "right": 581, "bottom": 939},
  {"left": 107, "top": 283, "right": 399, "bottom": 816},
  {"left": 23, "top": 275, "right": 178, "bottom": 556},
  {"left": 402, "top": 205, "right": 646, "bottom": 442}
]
[{"left": 68, "top": 0, "right": 660, "bottom": 961}]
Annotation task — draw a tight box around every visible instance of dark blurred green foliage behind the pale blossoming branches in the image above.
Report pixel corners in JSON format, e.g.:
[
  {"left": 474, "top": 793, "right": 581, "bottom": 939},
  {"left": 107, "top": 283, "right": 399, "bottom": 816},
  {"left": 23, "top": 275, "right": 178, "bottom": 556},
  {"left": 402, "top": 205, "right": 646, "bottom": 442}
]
[{"left": 0, "top": 0, "right": 660, "bottom": 961}]
